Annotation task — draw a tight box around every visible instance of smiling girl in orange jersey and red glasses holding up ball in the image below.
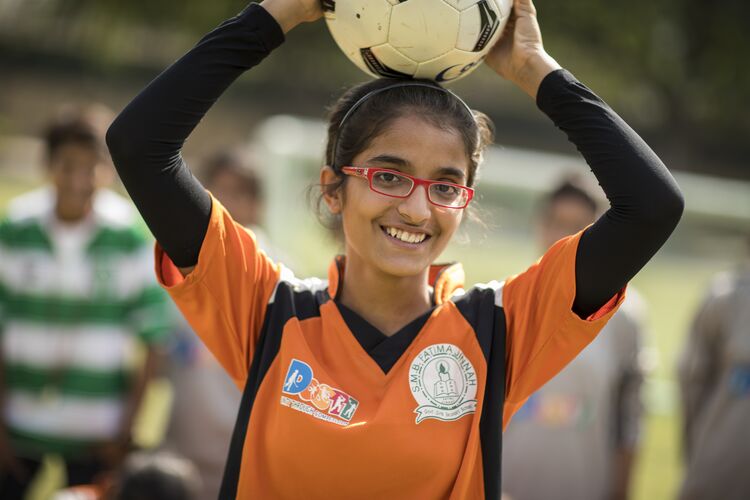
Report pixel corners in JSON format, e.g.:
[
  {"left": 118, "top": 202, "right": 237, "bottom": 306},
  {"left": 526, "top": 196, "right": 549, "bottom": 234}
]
[{"left": 108, "top": 0, "right": 683, "bottom": 499}]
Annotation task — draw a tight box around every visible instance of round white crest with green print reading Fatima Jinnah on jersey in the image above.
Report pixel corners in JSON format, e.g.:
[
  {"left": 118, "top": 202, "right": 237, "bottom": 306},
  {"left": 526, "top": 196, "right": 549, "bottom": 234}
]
[{"left": 409, "top": 344, "right": 477, "bottom": 423}]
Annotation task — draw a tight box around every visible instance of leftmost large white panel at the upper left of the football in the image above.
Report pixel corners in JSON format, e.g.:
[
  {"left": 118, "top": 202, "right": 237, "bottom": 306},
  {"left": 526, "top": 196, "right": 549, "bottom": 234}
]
[{"left": 326, "top": 0, "right": 393, "bottom": 48}]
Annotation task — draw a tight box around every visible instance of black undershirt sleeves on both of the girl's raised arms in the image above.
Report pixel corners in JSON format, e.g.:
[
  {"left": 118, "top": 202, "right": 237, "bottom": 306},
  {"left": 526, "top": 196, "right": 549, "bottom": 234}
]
[{"left": 107, "top": 4, "right": 683, "bottom": 317}]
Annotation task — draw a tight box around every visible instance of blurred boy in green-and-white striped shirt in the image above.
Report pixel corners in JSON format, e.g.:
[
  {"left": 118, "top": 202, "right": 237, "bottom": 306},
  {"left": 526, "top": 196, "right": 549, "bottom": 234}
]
[{"left": 0, "top": 106, "right": 169, "bottom": 500}]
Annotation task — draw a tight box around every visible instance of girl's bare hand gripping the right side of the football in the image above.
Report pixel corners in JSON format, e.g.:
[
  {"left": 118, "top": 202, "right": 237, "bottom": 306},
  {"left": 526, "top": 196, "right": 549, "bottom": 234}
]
[{"left": 484, "top": 0, "right": 560, "bottom": 98}]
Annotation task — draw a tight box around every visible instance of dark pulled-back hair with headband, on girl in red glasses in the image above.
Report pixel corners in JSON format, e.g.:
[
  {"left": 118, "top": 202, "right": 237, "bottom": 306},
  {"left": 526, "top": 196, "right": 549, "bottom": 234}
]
[{"left": 316, "top": 78, "right": 494, "bottom": 234}]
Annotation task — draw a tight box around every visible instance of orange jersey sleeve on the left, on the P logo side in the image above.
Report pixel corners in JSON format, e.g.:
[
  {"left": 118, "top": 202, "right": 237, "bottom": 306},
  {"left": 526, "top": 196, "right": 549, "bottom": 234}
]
[{"left": 156, "top": 199, "right": 281, "bottom": 387}]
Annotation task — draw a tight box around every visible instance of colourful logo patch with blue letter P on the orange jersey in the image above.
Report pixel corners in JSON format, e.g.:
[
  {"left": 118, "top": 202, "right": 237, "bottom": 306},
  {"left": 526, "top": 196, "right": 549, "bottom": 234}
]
[{"left": 281, "top": 359, "right": 359, "bottom": 425}]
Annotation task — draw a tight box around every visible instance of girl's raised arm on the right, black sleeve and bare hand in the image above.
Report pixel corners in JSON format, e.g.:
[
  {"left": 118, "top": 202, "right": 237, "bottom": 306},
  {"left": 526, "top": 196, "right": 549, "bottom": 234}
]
[{"left": 487, "top": 0, "right": 684, "bottom": 318}]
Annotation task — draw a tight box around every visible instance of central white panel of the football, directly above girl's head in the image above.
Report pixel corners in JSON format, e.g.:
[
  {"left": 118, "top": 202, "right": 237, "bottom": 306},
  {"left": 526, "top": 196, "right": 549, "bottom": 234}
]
[{"left": 388, "top": 0, "right": 459, "bottom": 61}]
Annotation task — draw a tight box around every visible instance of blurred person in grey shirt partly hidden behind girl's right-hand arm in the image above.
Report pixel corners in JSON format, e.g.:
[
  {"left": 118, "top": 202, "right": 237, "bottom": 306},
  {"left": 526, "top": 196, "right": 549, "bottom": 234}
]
[{"left": 503, "top": 177, "right": 644, "bottom": 500}]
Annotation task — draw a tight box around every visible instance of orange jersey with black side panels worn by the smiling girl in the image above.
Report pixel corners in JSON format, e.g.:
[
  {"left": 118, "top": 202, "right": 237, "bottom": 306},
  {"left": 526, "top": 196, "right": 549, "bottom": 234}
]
[{"left": 156, "top": 200, "right": 624, "bottom": 499}]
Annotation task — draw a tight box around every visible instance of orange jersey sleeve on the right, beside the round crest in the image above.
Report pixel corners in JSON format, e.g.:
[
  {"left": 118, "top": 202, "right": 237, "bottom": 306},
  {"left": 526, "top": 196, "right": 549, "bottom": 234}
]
[{"left": 502, "top": 231, "right": 625, "bottom": 427}]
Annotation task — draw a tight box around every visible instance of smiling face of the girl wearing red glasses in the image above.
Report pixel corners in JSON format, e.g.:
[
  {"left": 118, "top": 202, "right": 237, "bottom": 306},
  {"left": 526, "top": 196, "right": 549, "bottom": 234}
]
[{"left": 332, "top": 115, "right": 469, "bottom": 277}]
